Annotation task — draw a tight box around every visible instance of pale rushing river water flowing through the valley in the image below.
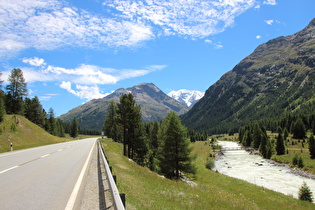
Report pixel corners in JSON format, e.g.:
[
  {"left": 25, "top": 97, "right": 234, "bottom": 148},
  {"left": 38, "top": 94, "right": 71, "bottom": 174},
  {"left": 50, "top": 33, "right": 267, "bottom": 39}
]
[{"left": 214, "top": 141, "right": 315, "bottom": 198}]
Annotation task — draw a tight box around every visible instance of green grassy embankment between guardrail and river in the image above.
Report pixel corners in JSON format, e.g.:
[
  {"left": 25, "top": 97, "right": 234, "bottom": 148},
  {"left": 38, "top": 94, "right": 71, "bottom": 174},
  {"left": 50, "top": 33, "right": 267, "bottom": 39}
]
[{"left": 102, "top": 139, "right": 314, "bottom": 209}]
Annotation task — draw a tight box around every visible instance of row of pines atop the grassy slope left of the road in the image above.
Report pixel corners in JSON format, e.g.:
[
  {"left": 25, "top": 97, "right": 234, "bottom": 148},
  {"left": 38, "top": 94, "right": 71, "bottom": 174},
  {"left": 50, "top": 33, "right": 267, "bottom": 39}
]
[{"left": 0, "top": 68, "right": 79, "bottom": 137}]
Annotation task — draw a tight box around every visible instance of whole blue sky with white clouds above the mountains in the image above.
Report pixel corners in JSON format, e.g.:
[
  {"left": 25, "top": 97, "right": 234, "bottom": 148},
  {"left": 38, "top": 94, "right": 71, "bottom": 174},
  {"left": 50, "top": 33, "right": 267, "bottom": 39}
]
[{"left": 0, "top": 0, "right": 315, "bottom": 116}]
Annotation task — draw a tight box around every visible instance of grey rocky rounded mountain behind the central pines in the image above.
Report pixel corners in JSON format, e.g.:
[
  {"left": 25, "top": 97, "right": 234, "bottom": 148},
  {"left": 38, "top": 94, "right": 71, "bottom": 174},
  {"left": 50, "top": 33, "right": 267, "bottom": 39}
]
[{"left": 59, "top": 83, "right": 188, "bottom": 130}]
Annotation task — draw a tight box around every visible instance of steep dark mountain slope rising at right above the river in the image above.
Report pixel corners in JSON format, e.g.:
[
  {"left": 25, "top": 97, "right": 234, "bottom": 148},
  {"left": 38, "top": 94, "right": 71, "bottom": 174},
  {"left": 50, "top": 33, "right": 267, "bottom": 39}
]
[{"left": 181, "top": 19, "right": 315, "bottom": 133}]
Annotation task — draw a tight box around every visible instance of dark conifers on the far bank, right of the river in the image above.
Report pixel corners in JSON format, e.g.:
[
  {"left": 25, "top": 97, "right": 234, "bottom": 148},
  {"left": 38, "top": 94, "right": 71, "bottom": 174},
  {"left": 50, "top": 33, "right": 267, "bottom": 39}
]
[{"left": 239, "top": 113, "right": 315, "bottom": 158}]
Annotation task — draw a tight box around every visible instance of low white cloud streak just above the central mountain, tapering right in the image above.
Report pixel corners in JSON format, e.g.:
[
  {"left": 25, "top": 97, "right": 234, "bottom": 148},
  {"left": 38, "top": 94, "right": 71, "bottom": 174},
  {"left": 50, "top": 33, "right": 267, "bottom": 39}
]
[{"left": 11, "top": 57, "right": 167, "bottom": 100}]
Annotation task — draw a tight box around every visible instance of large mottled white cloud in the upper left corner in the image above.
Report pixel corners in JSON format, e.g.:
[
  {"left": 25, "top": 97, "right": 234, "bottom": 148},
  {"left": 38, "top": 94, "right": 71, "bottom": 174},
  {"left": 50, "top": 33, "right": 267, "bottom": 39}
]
[{"left": 0, "top": 0, "right": 154, "bottom": 57}]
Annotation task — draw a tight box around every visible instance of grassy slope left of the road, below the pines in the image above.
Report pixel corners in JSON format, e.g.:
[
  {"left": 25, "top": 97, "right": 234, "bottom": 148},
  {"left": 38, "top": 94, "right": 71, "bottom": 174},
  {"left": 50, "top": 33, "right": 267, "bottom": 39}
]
[{"left": 0, "top": 115, "right": 65, "bottom": 152}]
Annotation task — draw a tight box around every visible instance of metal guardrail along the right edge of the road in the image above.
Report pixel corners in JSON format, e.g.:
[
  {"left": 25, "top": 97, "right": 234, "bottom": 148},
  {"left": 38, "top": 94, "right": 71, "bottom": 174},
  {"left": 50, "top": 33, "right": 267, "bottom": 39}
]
[{"left": 98, "top": 141, "right": 125, "bottom": 210}]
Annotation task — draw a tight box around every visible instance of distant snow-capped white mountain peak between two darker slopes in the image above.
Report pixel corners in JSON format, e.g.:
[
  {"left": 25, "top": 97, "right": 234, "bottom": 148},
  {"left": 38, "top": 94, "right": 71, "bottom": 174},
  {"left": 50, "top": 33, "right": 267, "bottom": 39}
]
[{"left": 167, "top": 89, "right": 205, "bottom": 108}]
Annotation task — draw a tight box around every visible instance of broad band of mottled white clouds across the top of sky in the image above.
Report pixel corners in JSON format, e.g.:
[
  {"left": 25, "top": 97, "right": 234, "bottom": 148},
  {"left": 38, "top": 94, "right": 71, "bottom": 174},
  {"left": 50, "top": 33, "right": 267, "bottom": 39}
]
[{"left": 0, "top": 0, "right": 266, "bottom": 58}]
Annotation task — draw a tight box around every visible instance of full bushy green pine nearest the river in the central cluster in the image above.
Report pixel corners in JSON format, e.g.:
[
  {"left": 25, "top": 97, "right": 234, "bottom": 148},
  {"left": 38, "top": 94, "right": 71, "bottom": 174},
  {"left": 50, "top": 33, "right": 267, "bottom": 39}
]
[{"left": 159, "top": 112, "right": 196, "bottom": 179}]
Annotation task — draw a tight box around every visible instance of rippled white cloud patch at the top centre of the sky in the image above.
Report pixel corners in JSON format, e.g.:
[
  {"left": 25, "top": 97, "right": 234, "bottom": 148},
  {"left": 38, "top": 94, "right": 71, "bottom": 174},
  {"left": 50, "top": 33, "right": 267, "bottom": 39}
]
[{"left": 103, "top": 0, "right": 255, "bottom": 38}]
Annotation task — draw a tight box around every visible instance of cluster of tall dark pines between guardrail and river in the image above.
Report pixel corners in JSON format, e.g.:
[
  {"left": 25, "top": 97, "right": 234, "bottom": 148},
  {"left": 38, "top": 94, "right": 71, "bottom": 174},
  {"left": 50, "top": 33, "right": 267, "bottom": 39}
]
[{"left": 103, "top": 93, "right": 207, "bottom": 179}]
